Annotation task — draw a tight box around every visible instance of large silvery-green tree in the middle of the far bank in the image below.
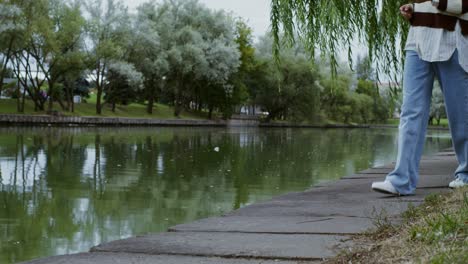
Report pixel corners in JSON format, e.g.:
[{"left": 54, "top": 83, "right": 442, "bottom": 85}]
[{"left": 134, "top": 0, "right": 243, "bottom": 116}]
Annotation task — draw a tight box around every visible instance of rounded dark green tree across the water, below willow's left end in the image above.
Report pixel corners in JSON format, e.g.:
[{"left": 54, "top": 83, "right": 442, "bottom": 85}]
[{"left": 249, "top": 36, "right": 320, "bottom": 121}]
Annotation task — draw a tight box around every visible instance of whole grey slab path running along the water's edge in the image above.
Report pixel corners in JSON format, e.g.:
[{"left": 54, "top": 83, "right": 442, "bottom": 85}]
[{"left": 22, "top": 152, "right": 457, "bottom": 264}]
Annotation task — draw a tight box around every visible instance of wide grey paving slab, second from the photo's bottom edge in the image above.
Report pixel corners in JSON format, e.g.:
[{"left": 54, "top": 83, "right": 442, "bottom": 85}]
[{"left": 91, "top": 232, "right": 350, "bottom": 260}]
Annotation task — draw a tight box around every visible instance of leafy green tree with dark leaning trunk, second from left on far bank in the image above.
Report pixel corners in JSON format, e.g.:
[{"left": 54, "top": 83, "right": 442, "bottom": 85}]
[{"left": 31, "top": 0, "right": 85, "bottom": 111}]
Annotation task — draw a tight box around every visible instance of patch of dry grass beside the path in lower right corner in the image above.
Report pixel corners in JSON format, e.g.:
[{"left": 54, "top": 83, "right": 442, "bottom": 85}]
[{"left": 328, "top": 188, "right": 468, "bottom": 263}]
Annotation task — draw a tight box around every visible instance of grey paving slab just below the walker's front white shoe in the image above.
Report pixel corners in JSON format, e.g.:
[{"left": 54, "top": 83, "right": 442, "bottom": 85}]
[{"left": 225, "top": 179, "right": 450, "bottom": 218}]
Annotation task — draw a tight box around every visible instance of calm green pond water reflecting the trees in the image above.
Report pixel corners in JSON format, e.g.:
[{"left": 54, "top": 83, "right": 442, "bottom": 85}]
[{"left": 0, "top": 127, "right": 451, "bottom": 263}]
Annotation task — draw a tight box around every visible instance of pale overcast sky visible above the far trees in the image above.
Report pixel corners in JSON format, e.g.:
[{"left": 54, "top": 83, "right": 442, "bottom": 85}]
[{"left": 123, "top": 0, "right": 270, "bottom": 37}]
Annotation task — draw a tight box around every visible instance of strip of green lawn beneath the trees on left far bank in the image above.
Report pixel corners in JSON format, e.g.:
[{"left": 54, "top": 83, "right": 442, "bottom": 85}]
[{"left": 0, "top": 99, "right": 207, "bottom": 119}]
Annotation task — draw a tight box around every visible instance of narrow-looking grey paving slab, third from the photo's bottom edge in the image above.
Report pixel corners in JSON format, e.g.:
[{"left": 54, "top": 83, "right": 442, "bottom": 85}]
[{"left": 169, "top": 216, "right": 374, "bottom": 235}]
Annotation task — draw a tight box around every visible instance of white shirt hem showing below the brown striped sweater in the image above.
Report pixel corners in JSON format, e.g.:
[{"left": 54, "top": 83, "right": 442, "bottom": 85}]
[{"left": 405, "top": 4, "right": 468, "bottom": 72}]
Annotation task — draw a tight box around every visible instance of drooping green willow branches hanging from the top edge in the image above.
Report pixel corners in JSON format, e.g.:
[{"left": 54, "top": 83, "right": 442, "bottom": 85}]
[{"left": 271, "top": 0, "right": 408, "bottom": 82}]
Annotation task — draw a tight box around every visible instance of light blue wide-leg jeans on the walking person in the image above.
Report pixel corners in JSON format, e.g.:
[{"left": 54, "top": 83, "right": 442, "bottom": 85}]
[{"left": 387, "top": 51, "right": 468, "bottom": 195}]
